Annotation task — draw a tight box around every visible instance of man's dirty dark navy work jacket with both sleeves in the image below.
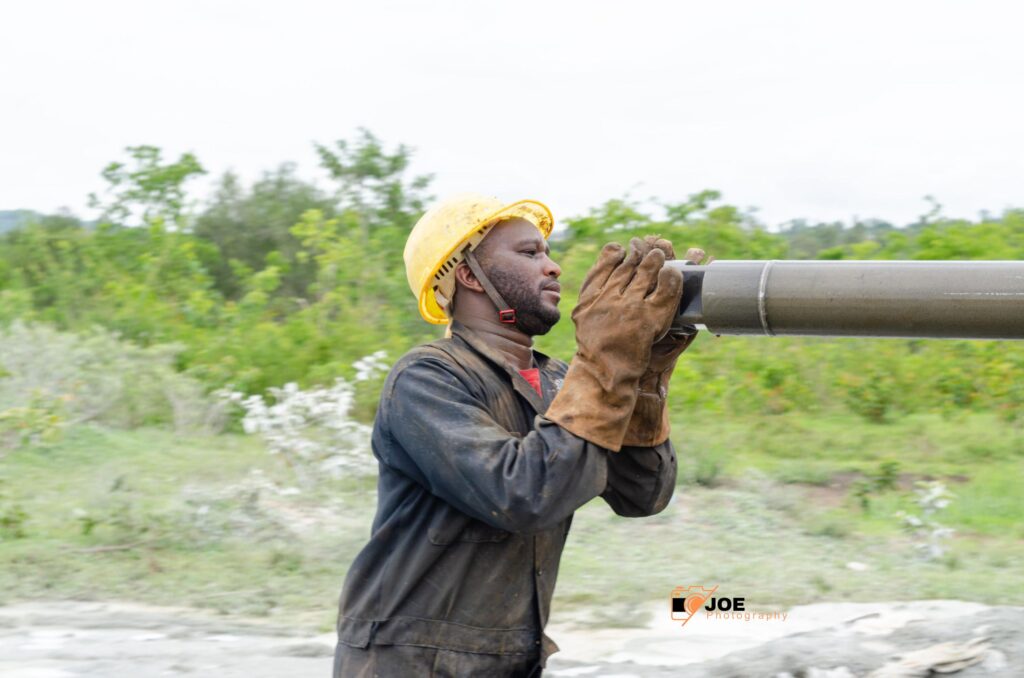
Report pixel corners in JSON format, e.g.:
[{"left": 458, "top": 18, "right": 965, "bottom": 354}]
[{"left": 338, "top": 324, "right": 676, "bottom": 666}]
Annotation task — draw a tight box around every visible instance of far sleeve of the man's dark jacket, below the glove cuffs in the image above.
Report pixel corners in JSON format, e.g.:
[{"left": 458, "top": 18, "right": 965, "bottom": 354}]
[{"left": 601, "top": 440, "right": 676, "bottom": 517}]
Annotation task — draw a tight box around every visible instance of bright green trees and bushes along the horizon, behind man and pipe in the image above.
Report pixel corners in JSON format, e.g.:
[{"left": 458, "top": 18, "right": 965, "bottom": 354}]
[{"left": 0, "top": 130, "right": 1024, "bottom": 422}]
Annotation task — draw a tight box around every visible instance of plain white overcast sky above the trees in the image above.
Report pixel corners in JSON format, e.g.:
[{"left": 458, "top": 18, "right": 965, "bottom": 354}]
[{"left": 0, "top": 0, "right": 1024, "bottom": 224}]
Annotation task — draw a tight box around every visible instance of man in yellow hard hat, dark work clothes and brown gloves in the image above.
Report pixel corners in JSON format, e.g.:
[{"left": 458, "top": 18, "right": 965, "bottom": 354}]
[{"left": 334, "top": 195, "right": 702, "bottom": 678}]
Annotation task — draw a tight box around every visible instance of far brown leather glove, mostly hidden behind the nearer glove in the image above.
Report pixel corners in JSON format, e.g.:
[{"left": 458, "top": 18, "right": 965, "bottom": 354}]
[{"left": 623, "top": 236, "right": 705, "bottom": 448}]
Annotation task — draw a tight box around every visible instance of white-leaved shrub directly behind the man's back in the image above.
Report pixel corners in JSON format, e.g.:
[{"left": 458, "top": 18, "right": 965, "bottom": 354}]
[{"left": 219, "top": 351, "right": 388, "bottom": 485}]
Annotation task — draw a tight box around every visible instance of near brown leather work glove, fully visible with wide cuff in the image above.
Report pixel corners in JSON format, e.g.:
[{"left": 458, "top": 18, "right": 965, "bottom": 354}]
[{"left": 545, "top": 238, "right": 683, "bottom": 452}]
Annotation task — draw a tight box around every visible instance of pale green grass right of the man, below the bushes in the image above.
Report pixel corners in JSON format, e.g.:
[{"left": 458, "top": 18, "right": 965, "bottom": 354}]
[{"left": 559, "top": 414, "right": 1024, "bottom": 621}]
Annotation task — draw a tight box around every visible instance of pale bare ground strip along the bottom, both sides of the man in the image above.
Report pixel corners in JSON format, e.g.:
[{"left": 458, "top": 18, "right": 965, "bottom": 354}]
[{"left": 0, "top": 601, "right": 1024, "bottom": 678}]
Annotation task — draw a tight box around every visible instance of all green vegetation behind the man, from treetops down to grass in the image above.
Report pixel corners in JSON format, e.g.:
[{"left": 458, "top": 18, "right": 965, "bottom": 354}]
[{"left": 0, "top": 132, "right": 1024, "bottom": 629}]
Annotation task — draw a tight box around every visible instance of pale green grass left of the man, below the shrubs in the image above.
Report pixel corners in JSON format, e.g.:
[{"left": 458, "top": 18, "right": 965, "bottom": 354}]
[{"left": 0, "top": 426, "right": 375, "bottom": 624}]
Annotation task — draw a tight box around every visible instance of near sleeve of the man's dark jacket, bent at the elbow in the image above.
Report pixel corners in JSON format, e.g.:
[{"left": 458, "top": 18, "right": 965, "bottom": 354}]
[{"left": 378, "top": 357, "right": 608, "bottom": 533}]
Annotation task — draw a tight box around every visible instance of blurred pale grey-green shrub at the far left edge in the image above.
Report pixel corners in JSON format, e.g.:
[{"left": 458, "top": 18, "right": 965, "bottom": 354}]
[{"left": 0, "top": 321, "right": 224, "bottom": 443}]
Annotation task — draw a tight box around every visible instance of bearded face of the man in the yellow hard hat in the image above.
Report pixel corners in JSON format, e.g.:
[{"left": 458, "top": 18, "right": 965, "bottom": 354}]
[{"left": 475, "top": 219, "right": 562, "bottom": 337}]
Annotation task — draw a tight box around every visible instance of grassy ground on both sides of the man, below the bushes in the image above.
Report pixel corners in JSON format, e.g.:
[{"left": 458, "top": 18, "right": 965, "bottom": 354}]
[{"left": 0, "top": 414, "right": 1024, "bottom": 629}]
